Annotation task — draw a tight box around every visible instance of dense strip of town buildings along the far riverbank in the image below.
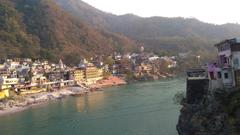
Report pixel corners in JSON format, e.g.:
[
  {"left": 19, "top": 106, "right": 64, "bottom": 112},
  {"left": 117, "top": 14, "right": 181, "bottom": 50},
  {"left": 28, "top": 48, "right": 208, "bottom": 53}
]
[{"left": 0, "top": 48, "right": 176, "bottom": 99}]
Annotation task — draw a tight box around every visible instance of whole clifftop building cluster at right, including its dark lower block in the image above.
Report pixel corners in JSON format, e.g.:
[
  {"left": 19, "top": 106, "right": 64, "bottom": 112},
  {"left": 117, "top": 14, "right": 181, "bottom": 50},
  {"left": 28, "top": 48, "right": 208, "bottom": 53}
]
[{"left": 186, "top": 38, "right": 240, "bottom": 104}]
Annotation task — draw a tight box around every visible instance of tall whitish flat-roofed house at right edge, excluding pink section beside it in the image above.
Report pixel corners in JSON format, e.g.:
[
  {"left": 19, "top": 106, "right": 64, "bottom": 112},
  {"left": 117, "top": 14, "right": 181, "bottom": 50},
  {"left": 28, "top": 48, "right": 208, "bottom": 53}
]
[{"left": 215, "top": 38, "right": 240, "bottom": 88}]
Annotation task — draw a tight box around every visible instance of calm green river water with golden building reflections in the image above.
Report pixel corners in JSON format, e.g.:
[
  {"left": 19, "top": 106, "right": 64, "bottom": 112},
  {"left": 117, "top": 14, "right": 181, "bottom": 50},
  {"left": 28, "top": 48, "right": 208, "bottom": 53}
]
[{"left": 0, "top": 79, "right": 185, "bottom": 135}]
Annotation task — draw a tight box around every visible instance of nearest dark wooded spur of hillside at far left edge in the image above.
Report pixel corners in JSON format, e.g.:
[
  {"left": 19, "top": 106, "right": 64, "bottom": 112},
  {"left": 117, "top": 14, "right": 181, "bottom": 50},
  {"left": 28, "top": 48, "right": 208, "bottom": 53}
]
[{"left": 0, "top": 0, "right": 40, "bottom": 58}]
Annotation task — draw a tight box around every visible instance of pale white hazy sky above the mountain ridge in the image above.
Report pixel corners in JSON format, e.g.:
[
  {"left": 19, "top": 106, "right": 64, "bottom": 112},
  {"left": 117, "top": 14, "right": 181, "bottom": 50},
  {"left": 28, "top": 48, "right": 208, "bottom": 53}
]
[{"left": 83, "top": 0, "right": 240, "bottom": 24}]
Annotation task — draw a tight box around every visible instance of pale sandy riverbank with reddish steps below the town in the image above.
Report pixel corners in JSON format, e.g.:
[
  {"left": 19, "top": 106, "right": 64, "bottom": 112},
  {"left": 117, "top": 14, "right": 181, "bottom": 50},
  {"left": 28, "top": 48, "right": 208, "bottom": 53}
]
[{"left": 0, "top": 76, "right": 127, "bottom": 116}]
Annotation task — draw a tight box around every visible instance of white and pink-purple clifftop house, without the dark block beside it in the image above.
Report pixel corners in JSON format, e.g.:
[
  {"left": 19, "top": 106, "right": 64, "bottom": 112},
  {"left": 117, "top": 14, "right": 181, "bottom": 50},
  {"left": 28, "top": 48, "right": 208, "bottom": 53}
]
[{"left": 208, "top": 38, "right": 240, "bottom": 89}]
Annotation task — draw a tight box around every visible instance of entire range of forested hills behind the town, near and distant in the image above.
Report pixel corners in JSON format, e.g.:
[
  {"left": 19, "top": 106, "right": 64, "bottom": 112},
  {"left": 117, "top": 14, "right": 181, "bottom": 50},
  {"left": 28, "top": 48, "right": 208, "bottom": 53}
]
[{"left": 0, "top": 0, "right": 240, "bottom": 63}]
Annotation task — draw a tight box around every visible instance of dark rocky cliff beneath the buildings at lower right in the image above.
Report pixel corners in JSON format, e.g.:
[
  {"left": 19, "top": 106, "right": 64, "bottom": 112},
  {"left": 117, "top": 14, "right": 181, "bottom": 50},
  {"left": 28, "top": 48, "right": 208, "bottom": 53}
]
[{"left": 177, "top": 91, "right": 240, "bottom": 135}]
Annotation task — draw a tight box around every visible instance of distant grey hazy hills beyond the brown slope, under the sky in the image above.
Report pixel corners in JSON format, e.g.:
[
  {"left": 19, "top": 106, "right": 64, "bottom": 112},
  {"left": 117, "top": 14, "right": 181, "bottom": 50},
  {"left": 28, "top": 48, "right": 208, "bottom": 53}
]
[{"left": 55, "top": 0, "right": 240, "bottom": 57}]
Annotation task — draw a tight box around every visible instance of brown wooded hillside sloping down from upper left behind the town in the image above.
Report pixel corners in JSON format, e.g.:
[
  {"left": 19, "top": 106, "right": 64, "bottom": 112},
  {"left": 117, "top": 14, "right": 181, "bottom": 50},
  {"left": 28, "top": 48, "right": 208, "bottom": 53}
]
[{"left": 0, "top": 0, "right": 136, "bottom": 63}]
